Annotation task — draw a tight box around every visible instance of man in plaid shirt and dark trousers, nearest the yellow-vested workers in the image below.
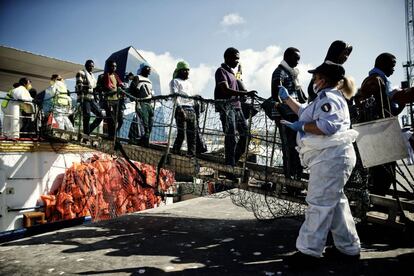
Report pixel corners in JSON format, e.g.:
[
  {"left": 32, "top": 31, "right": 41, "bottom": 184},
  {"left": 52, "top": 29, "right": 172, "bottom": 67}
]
[{"left": 75, "top": 59, "right": 104, "bottom": 135}]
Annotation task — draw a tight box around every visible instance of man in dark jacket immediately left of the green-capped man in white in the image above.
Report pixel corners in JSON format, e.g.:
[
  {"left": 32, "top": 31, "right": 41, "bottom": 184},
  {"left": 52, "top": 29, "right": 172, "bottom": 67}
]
[{"left": 129, "top": 62, "right": 154, "bottom": 147}]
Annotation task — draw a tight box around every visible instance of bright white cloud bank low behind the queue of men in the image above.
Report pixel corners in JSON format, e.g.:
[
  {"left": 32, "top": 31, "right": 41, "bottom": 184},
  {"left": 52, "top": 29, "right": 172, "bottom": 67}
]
[{"left": 139, "top": 45, "right": 313, "bottom": 99}]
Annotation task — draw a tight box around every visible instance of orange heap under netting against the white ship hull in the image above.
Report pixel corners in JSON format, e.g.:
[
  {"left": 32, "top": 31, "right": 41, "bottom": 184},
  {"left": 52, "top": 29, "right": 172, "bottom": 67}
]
[{"left": 41, "top": 155, "right": 175, "bottom": 221}]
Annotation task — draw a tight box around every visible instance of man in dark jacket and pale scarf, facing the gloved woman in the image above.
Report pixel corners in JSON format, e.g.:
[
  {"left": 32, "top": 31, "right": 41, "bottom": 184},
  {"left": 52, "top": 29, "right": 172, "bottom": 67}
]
[{"left": 271, "top": 47, "right": 306, "bottom": 179}]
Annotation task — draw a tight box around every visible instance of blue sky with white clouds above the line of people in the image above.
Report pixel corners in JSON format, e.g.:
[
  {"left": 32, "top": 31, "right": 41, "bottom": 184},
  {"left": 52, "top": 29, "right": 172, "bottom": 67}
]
[{"left": 0, "top": 0, "right": 407, "bottom": 97}]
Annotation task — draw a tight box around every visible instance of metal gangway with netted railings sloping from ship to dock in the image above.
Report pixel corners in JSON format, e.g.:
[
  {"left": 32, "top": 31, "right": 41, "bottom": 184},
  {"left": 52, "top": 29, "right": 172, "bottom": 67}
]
[{"left": 0, "top": 93, "right": 414, "bottom": 225}]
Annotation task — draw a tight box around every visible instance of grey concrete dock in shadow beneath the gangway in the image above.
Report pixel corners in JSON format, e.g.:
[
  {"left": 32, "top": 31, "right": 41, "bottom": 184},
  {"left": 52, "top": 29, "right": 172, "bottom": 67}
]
[{"left": 0, "top": 192, "right": 414, "bottom": 276}]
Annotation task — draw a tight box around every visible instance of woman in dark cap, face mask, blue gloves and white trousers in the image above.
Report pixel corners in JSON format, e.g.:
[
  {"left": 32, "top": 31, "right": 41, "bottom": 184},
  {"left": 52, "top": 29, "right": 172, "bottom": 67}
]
[{"left": 279, "top": 61, "right": 361, "bottom": 268}]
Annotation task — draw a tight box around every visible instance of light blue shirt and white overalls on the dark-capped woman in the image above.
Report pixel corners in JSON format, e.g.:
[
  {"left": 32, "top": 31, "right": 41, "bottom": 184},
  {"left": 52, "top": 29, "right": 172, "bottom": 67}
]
[{"left": 296, "top": 88, "right": 361, "bottom": 257}]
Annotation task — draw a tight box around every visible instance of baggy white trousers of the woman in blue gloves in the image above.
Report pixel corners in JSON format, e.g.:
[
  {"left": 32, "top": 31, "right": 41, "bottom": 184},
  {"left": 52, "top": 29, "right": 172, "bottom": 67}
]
[{"left": 296, "top": 143, "right": 361, "bottom": 257}]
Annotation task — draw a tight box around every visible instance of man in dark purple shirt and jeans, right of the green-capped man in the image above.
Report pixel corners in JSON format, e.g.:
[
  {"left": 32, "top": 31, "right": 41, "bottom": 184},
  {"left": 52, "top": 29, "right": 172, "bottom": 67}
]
[{"left": 214, "top": 47, "right": 257, "bottom": 166}]
